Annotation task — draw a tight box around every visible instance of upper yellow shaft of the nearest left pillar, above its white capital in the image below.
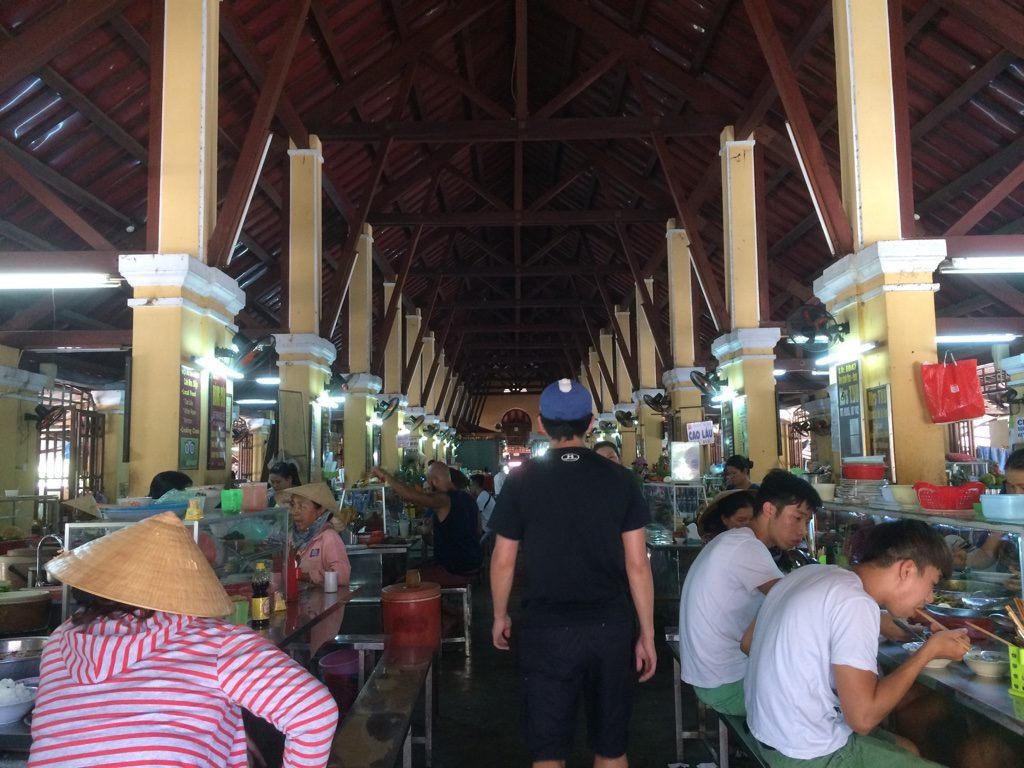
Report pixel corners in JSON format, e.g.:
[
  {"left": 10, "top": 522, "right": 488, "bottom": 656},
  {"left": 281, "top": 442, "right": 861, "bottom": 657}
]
[{"left": 157, "top": 0, "right": 220, "bottom": 262}]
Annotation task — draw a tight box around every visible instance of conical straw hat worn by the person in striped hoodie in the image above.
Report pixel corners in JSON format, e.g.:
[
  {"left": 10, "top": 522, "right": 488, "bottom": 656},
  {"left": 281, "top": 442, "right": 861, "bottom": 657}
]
[{"left": 46, "top": 512, "right": 233, "bottom": 617}]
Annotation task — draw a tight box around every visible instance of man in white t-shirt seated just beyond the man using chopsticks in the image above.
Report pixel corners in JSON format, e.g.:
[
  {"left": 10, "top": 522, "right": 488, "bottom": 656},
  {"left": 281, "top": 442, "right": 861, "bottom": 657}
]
[{"left": 679, "top": 471, "right": 821, "bottom": 716}]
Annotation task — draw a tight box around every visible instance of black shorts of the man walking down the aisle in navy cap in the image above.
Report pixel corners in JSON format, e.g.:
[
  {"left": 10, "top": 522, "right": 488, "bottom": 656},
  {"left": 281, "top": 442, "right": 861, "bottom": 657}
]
[{"left": 516, "top": 622, "right": 636, "bottom": 761}]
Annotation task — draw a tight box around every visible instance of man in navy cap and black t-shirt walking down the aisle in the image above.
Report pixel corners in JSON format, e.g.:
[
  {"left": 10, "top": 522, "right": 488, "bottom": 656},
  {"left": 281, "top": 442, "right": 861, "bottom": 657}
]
[{"left": 490, "top": 379, "right": 656, "bottom": 768}]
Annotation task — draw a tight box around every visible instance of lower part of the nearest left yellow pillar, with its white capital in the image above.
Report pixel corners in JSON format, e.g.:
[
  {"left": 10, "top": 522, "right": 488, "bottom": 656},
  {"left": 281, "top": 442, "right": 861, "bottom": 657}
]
[{"left": 118, "top": 254, "right": 246, "bottom": 496}]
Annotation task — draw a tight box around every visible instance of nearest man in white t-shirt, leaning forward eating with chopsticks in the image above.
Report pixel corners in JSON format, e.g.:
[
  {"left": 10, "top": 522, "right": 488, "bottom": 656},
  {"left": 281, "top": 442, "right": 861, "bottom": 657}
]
[{"left": 744, "top": 520, "right": 969, "bottom": 768}]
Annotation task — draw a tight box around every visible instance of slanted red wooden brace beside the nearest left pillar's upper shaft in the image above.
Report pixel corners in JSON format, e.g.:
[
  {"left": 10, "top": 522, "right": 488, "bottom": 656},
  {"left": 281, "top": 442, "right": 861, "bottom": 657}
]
[{"left": 207, "top": 0, "right": 310, "bottom": 267}]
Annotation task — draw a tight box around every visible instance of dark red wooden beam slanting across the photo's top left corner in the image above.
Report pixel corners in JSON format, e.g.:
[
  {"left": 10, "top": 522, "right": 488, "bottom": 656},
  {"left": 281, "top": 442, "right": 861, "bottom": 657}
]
[{"left": 0, "top": 0, "right": 131, "bottom": 93}]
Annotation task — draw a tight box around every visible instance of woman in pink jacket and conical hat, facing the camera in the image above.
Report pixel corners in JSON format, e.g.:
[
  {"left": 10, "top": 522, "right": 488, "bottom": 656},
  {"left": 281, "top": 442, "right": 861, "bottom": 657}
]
[{"left": 281, "top": 482, "right": 352, "bottom": 584}]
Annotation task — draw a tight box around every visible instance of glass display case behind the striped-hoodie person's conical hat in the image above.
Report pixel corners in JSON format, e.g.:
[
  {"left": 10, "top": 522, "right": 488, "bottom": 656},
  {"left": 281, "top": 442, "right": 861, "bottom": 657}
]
[{"left": 61, "top": 507, "right": 290, "bottom": 618}]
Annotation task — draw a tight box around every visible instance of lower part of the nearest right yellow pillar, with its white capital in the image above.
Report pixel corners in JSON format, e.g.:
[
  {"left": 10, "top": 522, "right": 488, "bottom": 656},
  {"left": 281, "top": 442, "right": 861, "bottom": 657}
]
[{"left": 814, "top": 240, "right": 946, "bottom": 483}]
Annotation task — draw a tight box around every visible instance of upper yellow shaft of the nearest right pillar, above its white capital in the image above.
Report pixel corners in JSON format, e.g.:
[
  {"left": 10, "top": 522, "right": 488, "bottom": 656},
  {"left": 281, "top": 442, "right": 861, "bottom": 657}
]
[{"left": 833, "top": 0, "right": 903, "bottom": 251}]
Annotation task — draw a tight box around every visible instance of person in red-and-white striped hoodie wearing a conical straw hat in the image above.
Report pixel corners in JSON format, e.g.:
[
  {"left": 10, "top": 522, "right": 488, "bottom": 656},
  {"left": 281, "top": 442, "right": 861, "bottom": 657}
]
[{"left": 29, "top": 512, "right": 338, "bottom": 768}]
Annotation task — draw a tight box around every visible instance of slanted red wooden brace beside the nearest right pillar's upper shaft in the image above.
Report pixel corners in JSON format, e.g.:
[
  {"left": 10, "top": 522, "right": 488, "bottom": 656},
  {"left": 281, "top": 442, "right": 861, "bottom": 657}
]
[{"left": 743, "top": 0, "right": 853, "bottom": 256}]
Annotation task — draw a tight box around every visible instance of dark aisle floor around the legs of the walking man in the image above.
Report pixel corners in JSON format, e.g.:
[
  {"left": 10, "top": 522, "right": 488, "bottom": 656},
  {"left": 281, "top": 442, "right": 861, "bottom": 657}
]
[{"left": 417, "top": 583, "right": 749, "bottom": 768}]
